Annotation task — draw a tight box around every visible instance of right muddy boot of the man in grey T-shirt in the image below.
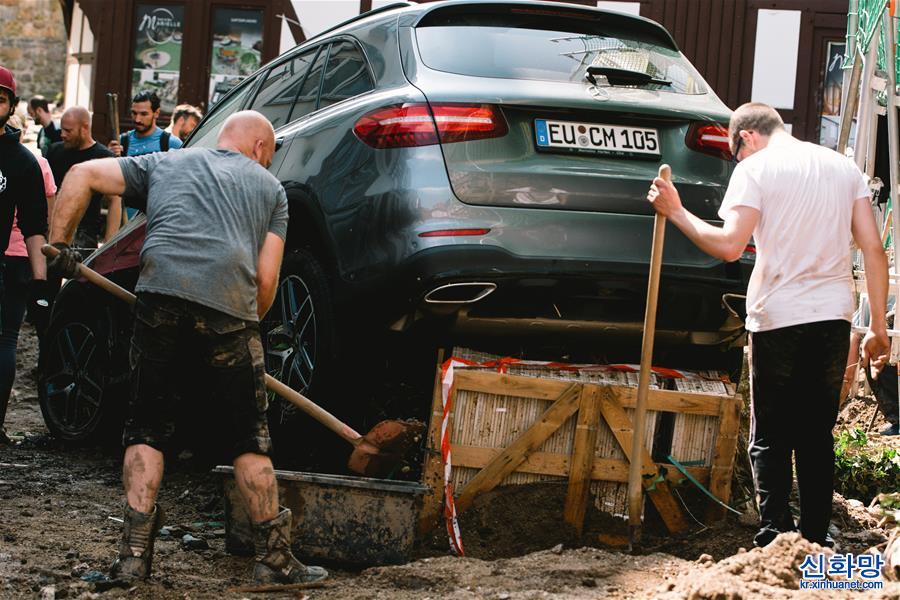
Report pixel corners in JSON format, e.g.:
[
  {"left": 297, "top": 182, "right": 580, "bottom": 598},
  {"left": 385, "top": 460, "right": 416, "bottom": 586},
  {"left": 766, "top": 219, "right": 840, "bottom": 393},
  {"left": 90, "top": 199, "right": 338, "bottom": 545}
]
[{"left": 253, "top": 508, "right": 328, "bottom": 583}]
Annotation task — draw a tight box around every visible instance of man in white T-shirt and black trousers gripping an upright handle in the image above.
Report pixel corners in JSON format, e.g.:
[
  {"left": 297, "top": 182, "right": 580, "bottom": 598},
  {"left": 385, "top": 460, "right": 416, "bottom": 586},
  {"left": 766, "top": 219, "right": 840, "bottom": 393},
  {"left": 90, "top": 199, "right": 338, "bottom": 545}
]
[{"left": 647, "top": 103, "right": 889, "bottom": 546}]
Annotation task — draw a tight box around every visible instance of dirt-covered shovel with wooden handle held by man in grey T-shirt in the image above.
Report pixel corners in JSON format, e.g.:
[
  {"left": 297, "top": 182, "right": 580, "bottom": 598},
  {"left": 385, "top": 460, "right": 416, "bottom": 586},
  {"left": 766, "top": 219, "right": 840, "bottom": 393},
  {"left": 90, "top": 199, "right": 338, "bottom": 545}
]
[{"left": 41, "top": 245, "right": 425, "bottom": 477}]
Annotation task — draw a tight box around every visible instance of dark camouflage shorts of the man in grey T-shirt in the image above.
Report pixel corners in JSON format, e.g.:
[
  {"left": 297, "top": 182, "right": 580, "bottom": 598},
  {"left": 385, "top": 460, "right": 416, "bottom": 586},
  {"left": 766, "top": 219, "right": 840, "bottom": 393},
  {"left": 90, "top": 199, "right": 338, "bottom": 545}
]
[{"left": 122, "top": 293, "right": 272, "bottom": 458}]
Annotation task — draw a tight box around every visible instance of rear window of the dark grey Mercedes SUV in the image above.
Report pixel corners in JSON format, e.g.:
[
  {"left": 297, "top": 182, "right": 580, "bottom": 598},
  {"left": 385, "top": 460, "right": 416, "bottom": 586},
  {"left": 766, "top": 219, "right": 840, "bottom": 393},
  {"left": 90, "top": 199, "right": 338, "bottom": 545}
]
[{"left": 416, "top": 10, "right": 707, "bottom": 94}]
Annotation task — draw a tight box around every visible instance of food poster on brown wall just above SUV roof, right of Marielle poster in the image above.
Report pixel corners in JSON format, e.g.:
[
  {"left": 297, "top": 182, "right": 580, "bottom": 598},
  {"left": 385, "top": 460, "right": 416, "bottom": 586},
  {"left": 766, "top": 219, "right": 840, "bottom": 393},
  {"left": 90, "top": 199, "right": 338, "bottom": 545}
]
[{"left": 209, "top": 8, "right": 263, "bottom": 106}]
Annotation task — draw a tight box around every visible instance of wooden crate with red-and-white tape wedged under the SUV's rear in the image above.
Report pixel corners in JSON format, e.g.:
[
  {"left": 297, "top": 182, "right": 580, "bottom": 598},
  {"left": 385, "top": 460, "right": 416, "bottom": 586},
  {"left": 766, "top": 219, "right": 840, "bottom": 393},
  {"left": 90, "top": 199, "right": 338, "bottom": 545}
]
[{"left": 419, "top": 350, "right": 741, "bottom": 532}]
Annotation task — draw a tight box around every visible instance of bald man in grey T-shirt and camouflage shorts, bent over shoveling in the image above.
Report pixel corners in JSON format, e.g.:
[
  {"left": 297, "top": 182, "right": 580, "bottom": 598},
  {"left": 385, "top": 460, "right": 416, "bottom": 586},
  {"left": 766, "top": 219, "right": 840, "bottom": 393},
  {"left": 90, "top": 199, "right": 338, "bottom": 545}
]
[{"left": 48, "top": 111, "right": 327, "bottom": 583}]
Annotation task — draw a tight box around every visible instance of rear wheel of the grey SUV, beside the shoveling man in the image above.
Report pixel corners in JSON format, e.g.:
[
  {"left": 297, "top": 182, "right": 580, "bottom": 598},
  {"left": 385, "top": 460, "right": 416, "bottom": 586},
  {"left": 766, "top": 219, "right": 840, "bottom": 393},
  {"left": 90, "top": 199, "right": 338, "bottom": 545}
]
[{"left": 260, "top": 250, "right": 335, "bottom": 423}]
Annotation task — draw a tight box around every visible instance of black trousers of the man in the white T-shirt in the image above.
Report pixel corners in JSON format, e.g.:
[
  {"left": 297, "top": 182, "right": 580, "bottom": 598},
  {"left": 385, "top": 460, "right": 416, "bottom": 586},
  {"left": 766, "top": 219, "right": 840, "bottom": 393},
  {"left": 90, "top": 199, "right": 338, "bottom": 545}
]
[{"left": 750, "top": 321, "right": 850, "bottom": 546}]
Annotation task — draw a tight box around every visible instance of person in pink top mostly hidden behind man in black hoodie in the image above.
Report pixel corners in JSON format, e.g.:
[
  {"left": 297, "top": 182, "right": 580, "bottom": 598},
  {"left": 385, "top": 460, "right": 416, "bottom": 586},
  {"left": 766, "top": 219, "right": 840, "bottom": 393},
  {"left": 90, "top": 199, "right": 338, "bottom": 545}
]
[{"left": 0, "top": 114, "right": 56, "bottom": 435}]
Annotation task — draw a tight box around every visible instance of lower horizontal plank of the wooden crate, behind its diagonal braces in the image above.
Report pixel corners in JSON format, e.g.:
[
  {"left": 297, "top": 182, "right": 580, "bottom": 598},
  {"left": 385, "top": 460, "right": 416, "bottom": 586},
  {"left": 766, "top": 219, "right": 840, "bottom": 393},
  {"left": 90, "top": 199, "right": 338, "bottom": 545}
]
[{"left": 450, "top": 444, "right": 710, "bottom": 485}]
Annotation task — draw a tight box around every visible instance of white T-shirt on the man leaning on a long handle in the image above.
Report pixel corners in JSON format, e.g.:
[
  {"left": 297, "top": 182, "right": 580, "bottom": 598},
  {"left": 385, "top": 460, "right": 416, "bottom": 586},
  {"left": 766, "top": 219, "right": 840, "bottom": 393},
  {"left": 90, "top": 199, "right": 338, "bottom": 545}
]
[{"left": 719, "top": 136, "right": 869, "bottom": 331}]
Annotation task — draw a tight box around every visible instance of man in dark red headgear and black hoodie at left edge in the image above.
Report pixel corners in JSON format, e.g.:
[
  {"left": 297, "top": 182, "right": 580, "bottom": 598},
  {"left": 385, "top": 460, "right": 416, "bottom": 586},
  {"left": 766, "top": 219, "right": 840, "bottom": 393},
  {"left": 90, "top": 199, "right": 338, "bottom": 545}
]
[{"left": 0, "top": 66, "right": 51, "bottom": 445}]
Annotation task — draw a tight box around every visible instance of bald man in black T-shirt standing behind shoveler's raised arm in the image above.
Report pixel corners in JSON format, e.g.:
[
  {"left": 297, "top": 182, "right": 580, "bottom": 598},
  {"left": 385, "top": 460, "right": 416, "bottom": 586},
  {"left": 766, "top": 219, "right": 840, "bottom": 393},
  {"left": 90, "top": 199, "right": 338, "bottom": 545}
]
[{"left": 47, "top": 106, "right": 122, "bottom": 248}]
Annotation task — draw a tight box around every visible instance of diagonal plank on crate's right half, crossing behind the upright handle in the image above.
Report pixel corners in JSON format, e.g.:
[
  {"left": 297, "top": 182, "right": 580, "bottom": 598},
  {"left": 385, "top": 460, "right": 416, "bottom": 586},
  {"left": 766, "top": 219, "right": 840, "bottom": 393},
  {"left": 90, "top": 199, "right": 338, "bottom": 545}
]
[{"left": 600, "top": 388, "right": 688, "bottom": 533}]
